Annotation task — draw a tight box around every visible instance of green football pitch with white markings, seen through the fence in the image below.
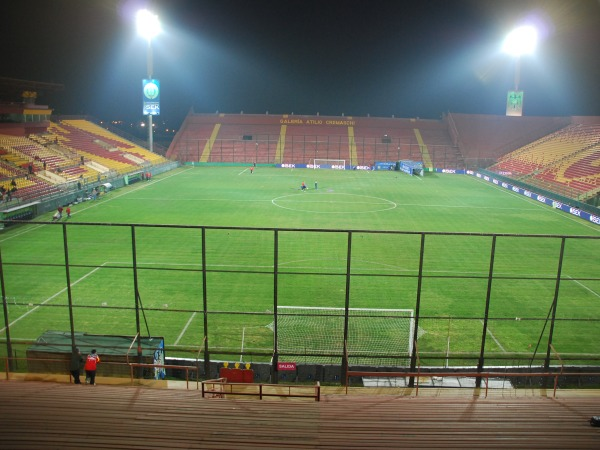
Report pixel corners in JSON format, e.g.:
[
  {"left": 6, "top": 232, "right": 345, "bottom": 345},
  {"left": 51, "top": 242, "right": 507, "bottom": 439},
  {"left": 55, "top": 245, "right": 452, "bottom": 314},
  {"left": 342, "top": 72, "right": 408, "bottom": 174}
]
[{"left": 0, "top": 166, "right": 600, "bottom": 365}]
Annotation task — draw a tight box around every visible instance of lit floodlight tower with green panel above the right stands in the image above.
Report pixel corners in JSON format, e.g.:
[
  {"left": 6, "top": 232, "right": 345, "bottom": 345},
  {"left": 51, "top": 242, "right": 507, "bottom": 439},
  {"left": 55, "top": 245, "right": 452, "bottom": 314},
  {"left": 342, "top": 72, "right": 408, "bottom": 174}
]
[{"left": 502, "top": 25, "right": 537, "bottom": 116}]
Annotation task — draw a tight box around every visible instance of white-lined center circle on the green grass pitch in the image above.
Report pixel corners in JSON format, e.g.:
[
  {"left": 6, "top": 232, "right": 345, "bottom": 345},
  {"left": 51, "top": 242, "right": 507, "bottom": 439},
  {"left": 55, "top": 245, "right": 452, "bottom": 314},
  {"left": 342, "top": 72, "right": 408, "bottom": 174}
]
[{"left": 271, "top": 192, "right": 397, "bottom": 214}]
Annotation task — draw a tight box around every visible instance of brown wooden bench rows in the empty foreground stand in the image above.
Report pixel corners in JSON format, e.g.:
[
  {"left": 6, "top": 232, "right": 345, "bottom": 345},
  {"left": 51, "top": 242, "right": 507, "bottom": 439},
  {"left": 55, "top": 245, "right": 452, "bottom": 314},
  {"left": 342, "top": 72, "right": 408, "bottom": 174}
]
[{"left": 0, "top": 381, "right": 600, "bottom": 450}]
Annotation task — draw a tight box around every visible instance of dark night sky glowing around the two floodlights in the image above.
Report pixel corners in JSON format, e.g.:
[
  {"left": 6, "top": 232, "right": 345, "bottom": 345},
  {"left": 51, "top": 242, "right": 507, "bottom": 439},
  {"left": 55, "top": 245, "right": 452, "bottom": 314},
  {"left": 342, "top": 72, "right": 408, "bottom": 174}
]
[{"left": 0, "top": 0, "right": 600, "bottom": 126}]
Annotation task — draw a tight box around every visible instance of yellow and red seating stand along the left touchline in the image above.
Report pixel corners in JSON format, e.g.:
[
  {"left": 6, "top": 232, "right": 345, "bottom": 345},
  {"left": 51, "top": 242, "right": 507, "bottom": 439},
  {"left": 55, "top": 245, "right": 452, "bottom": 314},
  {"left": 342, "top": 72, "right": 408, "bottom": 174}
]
[{"left": 0, "top": 108, "right": 169, "bottom": 208}]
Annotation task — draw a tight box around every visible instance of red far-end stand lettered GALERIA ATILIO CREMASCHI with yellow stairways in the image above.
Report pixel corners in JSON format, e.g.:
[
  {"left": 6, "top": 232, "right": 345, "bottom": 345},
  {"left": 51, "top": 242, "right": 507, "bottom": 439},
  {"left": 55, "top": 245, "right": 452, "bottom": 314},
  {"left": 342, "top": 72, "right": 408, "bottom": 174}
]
[{"left": 167, "top": 113, "right": 462, "bottom": 168}]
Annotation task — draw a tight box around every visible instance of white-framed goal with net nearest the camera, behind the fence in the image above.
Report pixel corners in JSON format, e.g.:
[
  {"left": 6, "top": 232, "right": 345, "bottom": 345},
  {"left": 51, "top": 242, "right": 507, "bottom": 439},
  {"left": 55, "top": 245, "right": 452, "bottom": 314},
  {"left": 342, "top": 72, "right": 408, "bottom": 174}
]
[{"left": 277, "top": 306, "right": 414, "bottom": 367}]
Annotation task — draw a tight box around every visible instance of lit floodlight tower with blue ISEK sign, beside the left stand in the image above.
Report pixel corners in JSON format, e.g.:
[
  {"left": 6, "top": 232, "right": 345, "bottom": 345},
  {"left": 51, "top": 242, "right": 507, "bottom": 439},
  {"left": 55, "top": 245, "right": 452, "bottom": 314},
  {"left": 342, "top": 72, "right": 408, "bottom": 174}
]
[{"left": 136, "top": 9, "right": 161, "bottom": 152}]
